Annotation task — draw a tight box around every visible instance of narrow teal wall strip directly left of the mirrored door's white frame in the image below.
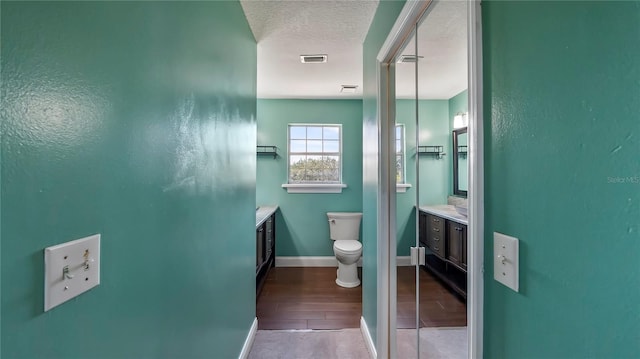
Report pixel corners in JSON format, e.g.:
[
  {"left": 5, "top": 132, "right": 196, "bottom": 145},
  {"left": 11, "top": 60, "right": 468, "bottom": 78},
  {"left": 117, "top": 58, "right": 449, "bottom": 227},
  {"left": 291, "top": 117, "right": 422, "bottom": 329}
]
[{"left": 362, "top": 0, "right": 405, "bottom": 348}]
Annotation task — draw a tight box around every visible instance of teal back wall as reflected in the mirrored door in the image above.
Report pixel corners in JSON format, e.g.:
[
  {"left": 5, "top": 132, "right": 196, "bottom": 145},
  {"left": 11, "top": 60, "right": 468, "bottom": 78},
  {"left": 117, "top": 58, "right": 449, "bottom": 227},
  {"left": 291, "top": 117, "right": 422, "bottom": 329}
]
[{"left": 396, "top": 100, "right": 451, "bottom": 256}]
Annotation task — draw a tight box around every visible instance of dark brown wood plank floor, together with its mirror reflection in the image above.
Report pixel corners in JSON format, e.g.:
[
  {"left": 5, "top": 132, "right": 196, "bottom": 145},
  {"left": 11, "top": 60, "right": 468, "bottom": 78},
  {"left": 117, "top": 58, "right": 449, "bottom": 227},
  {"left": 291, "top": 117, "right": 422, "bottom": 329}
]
[{"left": 256, "top": 267, "right": 467, "bottom": 329}]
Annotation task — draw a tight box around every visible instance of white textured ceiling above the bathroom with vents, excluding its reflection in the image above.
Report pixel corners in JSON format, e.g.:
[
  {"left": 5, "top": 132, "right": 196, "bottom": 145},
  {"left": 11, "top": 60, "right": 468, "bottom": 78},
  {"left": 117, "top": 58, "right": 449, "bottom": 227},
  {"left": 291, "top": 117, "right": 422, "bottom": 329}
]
[{"left": 241, "top": 0, "right": 378, "bottom": 98}]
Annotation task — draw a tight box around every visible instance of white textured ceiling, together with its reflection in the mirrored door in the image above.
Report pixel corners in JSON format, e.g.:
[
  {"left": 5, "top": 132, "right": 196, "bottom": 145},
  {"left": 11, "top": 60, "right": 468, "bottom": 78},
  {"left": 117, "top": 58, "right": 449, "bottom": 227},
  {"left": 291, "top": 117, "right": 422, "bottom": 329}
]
[{"left": 241, "top": 0, "right": 467, "bottom": 99}]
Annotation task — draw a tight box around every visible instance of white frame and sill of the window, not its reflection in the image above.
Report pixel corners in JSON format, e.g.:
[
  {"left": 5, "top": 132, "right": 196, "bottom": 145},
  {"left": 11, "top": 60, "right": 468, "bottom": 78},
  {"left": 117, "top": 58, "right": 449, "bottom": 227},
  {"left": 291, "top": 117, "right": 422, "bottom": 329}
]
[{"left": 282, "top": 123, "right": 347, "bottom": 193}]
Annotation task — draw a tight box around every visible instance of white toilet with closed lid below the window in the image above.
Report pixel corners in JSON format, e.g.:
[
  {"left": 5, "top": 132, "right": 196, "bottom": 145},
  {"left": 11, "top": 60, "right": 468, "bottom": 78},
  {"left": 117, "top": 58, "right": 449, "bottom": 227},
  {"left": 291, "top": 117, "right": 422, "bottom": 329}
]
[{"left": 327, "top": 212, "right": 362, "bottom": 288}]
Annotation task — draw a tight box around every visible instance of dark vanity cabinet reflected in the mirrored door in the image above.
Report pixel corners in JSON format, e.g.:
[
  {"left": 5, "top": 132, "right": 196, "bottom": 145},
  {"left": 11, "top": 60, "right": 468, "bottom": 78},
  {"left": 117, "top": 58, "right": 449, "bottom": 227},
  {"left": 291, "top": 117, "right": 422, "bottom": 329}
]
[{"left": 419, "top": 212, "right": 467, "bottom": 299}]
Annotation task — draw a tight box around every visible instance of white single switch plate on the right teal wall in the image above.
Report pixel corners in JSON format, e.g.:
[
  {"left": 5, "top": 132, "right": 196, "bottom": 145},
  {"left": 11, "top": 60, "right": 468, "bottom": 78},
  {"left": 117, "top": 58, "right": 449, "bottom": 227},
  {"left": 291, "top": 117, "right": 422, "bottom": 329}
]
[{"left": 493, "top": 232, "right": 519, "bottom": 292}]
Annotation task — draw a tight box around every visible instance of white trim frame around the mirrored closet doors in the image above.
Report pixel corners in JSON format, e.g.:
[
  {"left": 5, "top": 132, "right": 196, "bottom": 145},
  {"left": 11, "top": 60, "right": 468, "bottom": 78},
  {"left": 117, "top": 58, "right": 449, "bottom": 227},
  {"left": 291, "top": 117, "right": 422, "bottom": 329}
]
[{"left": 376, "top": 0, "right": 484, "bottom": 358}]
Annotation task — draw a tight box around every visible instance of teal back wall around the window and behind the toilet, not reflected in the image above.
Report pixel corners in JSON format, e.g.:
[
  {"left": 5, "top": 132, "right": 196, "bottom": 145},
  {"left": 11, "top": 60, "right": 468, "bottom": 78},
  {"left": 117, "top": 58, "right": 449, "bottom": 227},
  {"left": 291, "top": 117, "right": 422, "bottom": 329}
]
[{"left": 256, "top": 99, "right": 362, "bottom": 257}]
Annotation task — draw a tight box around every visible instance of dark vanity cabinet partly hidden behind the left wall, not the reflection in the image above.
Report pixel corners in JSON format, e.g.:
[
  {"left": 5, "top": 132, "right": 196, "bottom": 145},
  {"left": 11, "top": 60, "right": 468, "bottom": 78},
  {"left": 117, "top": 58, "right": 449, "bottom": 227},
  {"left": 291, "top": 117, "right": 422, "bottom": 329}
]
[{"left": 256, "top": 213, "right": 276, "bottom": 295}]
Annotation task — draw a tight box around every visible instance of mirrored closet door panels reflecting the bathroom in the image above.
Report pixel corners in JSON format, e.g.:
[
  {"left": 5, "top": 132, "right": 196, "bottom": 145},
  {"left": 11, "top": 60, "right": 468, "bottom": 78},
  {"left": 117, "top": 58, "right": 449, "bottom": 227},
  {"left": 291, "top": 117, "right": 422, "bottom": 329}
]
[{"left": 394, "top": 0, "right": 468, "bottom": 358}]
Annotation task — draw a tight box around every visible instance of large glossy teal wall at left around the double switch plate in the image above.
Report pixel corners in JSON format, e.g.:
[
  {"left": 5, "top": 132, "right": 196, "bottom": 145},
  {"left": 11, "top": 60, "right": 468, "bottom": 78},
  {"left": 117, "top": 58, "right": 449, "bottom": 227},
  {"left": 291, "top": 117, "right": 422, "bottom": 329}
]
[{"left": 1, "top": 1, "right": 256, "bottom": 358}]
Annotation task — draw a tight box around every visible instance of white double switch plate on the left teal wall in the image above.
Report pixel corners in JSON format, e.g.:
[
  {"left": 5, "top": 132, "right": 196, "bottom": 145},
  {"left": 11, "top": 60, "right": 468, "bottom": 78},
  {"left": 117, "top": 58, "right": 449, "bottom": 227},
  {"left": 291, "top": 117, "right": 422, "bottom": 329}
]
[{"left": 44, "top": 234, "right": 100, "bottom": 312}]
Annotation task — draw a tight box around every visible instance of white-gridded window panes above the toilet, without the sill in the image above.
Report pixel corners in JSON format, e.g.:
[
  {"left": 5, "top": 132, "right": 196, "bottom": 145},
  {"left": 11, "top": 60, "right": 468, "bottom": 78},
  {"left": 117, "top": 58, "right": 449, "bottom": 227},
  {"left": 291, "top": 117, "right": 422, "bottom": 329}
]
[{"left": 289, "top": 124, "right": 342, "bottom": 184}]
